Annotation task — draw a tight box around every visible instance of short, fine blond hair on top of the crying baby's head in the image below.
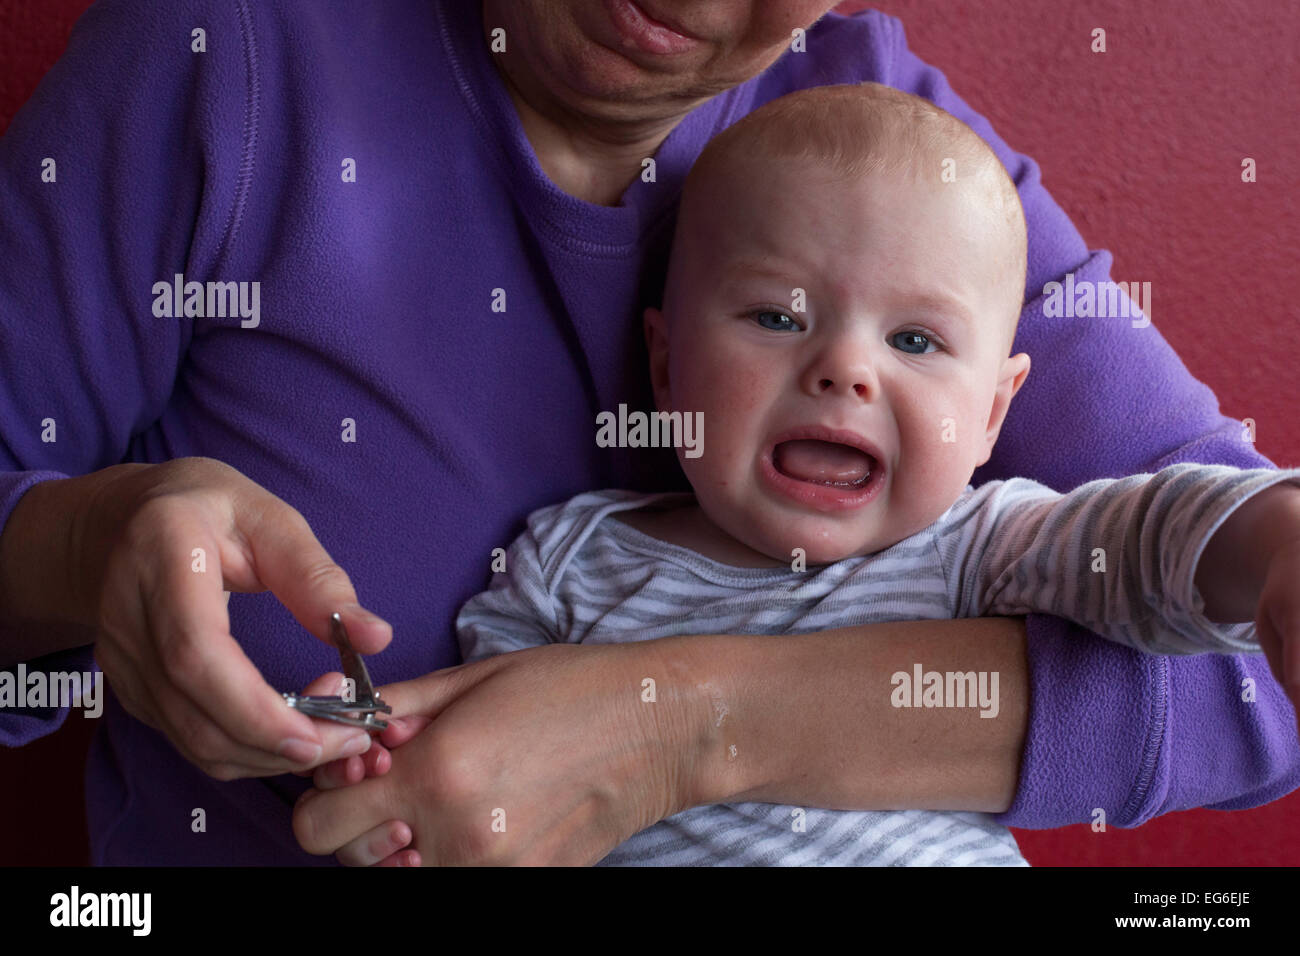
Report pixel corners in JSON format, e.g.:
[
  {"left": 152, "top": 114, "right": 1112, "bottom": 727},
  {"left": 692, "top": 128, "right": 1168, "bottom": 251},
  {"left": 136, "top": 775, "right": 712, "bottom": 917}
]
[{"left": 679, "top": 83, "right": 1028, "bottom": 354}]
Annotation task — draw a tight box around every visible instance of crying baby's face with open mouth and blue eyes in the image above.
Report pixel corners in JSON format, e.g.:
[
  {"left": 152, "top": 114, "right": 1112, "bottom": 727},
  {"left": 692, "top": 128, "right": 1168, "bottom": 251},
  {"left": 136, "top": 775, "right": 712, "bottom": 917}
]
[{"left": 646, "top": 153, "right": 1030, "bottom": 564}]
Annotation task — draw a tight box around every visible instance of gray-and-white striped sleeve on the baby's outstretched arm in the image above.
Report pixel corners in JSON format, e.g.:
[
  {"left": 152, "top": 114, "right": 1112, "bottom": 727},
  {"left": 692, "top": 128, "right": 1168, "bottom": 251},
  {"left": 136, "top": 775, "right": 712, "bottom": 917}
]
[{"left": 936, "top": 463, "right": 1300, "bottom": 654}]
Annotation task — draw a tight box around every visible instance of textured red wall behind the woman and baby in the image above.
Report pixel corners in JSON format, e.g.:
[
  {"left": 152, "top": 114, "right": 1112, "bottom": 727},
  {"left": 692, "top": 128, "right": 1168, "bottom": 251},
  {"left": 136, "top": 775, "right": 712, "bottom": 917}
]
[{"left": 0, "top": 0, "right": 1300, "bottom": 866}]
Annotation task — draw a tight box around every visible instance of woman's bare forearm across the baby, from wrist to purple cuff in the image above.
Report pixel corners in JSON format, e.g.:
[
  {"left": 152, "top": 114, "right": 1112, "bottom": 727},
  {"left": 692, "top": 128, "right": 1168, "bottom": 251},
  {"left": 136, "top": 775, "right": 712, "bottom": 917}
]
[{"left": 654, "top": 618, "right": 1028, "bottom": 813}]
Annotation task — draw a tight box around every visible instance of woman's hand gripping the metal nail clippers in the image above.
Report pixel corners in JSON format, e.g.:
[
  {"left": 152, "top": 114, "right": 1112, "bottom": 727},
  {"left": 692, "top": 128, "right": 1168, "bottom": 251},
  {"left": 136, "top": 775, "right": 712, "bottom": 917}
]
[{"left": 74, "top": 458, "right": 393, "bottom": 780}]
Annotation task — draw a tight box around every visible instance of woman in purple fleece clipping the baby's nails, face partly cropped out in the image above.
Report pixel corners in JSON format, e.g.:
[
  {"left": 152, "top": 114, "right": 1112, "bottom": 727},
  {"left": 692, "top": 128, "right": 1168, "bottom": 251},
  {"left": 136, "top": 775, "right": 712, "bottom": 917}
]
[{"left": 0, "top": 0, "right": 1300, "bottom": 864}]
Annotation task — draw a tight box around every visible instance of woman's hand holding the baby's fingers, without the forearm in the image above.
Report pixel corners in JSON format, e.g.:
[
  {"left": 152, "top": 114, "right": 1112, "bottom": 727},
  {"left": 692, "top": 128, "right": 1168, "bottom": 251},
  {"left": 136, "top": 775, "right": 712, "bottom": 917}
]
[{"left": 294, "top": 641, "right": 712, "bottom": 866}]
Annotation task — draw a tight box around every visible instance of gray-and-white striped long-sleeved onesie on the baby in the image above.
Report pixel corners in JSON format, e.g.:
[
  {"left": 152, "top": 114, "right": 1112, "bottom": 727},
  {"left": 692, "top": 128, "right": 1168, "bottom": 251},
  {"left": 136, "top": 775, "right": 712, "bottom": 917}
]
[{"left": 456, "top": 463, "right": 1300, "bottom": 866}]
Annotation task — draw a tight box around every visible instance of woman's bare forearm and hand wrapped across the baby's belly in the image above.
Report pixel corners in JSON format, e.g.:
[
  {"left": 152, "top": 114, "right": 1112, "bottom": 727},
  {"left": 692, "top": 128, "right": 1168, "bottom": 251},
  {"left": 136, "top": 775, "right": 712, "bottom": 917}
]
[{"left": 294, "top": 618, "right": 1027, "bottom": 866}]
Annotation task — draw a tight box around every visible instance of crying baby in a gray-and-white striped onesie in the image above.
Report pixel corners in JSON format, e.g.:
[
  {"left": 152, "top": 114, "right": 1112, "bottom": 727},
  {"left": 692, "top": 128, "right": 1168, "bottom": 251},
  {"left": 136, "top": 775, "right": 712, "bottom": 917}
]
[{"left": 458, "top": 83, "right": 1300, "bottom": 865}]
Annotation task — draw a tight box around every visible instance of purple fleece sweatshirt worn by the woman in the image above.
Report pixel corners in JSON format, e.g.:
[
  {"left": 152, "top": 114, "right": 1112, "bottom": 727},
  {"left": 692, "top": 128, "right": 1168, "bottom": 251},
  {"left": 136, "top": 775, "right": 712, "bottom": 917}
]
[{"left": 0, "top": 0, "right": 1300, "bottom": 864}]
